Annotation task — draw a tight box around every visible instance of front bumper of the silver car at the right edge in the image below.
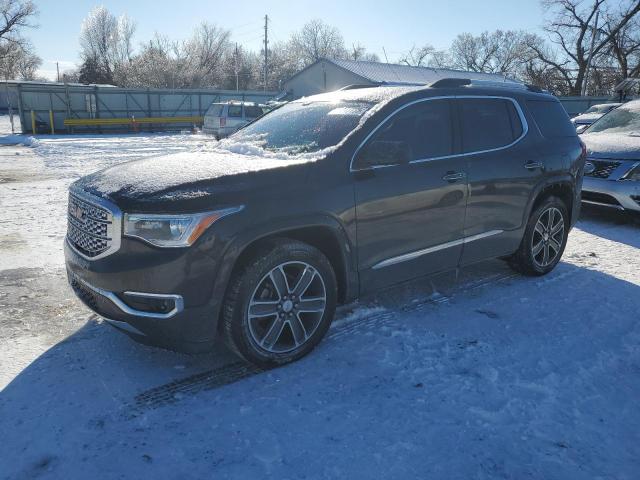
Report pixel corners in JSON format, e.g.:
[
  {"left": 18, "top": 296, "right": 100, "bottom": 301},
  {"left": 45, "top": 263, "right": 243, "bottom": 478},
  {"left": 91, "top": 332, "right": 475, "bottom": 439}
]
[{"left": 582, "top": 176, "right": 640, "bottom": 212}]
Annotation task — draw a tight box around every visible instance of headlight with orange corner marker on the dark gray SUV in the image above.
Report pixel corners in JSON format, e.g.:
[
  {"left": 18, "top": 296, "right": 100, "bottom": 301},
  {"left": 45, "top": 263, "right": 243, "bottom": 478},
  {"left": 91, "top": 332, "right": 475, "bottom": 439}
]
[{"left": 124, "top": 207, "right": 243, "bottom": 247}]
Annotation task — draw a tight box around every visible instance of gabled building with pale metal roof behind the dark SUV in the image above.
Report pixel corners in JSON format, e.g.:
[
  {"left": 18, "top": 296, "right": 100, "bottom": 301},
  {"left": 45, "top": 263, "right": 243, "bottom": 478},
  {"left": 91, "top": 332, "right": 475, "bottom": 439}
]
[{"left": 283, "top": 58, "right": 514, "bottom": 98}]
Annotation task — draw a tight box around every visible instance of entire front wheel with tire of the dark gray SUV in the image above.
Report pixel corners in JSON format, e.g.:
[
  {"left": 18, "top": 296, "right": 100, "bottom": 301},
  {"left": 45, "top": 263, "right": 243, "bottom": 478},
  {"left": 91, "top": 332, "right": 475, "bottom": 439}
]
[{"left": 222, "top": 239, "right": 337, "bottom": 368}]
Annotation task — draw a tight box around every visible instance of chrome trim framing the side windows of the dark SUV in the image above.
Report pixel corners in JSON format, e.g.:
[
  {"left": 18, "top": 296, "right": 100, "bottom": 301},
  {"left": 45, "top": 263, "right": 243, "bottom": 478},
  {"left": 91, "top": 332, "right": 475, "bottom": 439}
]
[{"left": 349, "top": 95, "right": 529, "bottom": 172}]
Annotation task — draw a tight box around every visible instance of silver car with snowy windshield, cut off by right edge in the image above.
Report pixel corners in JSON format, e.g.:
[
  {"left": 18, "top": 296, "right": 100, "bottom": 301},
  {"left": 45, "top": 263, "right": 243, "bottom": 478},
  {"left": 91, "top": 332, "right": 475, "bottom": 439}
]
[{"left": 581, "top": 100, "right": 640, "bottom": 212}]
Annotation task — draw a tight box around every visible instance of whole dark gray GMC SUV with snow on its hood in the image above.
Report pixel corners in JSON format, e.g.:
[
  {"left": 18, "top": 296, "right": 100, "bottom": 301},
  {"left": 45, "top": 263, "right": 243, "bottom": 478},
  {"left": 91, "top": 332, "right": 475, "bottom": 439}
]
[{"left": 65, "top": 79, "right": 585, "bottom": 367}]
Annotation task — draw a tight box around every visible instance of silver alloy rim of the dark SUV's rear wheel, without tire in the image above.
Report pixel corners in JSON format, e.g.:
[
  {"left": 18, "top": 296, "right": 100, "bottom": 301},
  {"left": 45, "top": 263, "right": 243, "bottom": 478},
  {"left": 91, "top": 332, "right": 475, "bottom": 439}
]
[{"left": 531, "top": 207, "right": 564, "bottom": 268}]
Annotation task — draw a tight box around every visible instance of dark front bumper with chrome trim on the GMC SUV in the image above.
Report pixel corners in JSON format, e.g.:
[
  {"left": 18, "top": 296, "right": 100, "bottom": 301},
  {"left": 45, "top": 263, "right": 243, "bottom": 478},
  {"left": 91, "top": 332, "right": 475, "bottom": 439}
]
[{"left": 64, "top": 240, "right": 220, "bottom": 352}]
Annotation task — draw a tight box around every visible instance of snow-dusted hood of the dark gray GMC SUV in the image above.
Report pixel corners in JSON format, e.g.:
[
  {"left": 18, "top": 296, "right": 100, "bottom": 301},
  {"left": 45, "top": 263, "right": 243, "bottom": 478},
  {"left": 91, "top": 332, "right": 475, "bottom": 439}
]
[{"left": 72, "top": 149, "right": 318, "bottom": 210}]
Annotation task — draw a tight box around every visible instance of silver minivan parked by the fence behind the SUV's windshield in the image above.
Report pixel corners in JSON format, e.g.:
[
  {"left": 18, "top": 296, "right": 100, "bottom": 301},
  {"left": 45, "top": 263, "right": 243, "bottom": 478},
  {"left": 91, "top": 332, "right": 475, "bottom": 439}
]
[{"left": 202, "top": 101, "right": 269, "bottom": 139}]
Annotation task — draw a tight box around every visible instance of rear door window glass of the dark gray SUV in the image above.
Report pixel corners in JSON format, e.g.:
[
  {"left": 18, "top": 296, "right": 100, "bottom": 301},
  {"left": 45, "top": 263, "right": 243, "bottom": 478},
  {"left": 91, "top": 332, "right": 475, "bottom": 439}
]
[{"left": 456, "top": 98, "right": 523, "bottom": 153}]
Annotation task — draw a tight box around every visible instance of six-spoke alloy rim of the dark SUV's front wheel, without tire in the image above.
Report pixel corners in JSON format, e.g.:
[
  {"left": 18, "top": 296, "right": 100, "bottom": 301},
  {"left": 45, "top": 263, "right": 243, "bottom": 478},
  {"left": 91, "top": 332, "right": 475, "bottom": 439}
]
[{"left": 247, "top": 261, "right": 327, "bottom": 353}]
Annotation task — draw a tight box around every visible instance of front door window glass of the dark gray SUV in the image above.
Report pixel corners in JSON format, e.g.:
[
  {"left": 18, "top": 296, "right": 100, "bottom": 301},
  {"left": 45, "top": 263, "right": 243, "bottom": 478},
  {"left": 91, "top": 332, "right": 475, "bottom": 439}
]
[{"left": 360, "top": 100, "right": 453, "bottom": 164}]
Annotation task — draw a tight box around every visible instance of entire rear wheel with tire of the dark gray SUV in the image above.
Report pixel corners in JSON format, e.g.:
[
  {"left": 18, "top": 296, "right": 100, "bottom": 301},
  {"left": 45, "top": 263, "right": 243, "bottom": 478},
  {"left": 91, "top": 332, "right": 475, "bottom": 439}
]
[{"left": 509, "top": 197, "right": 569, "bottom": 276}]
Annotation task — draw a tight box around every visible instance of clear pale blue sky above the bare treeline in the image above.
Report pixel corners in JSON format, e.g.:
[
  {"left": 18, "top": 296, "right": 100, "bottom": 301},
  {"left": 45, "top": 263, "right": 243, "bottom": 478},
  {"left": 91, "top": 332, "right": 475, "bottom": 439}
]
[{"left": 27, "top": 0, "right": 543, "bottom": 78}]
